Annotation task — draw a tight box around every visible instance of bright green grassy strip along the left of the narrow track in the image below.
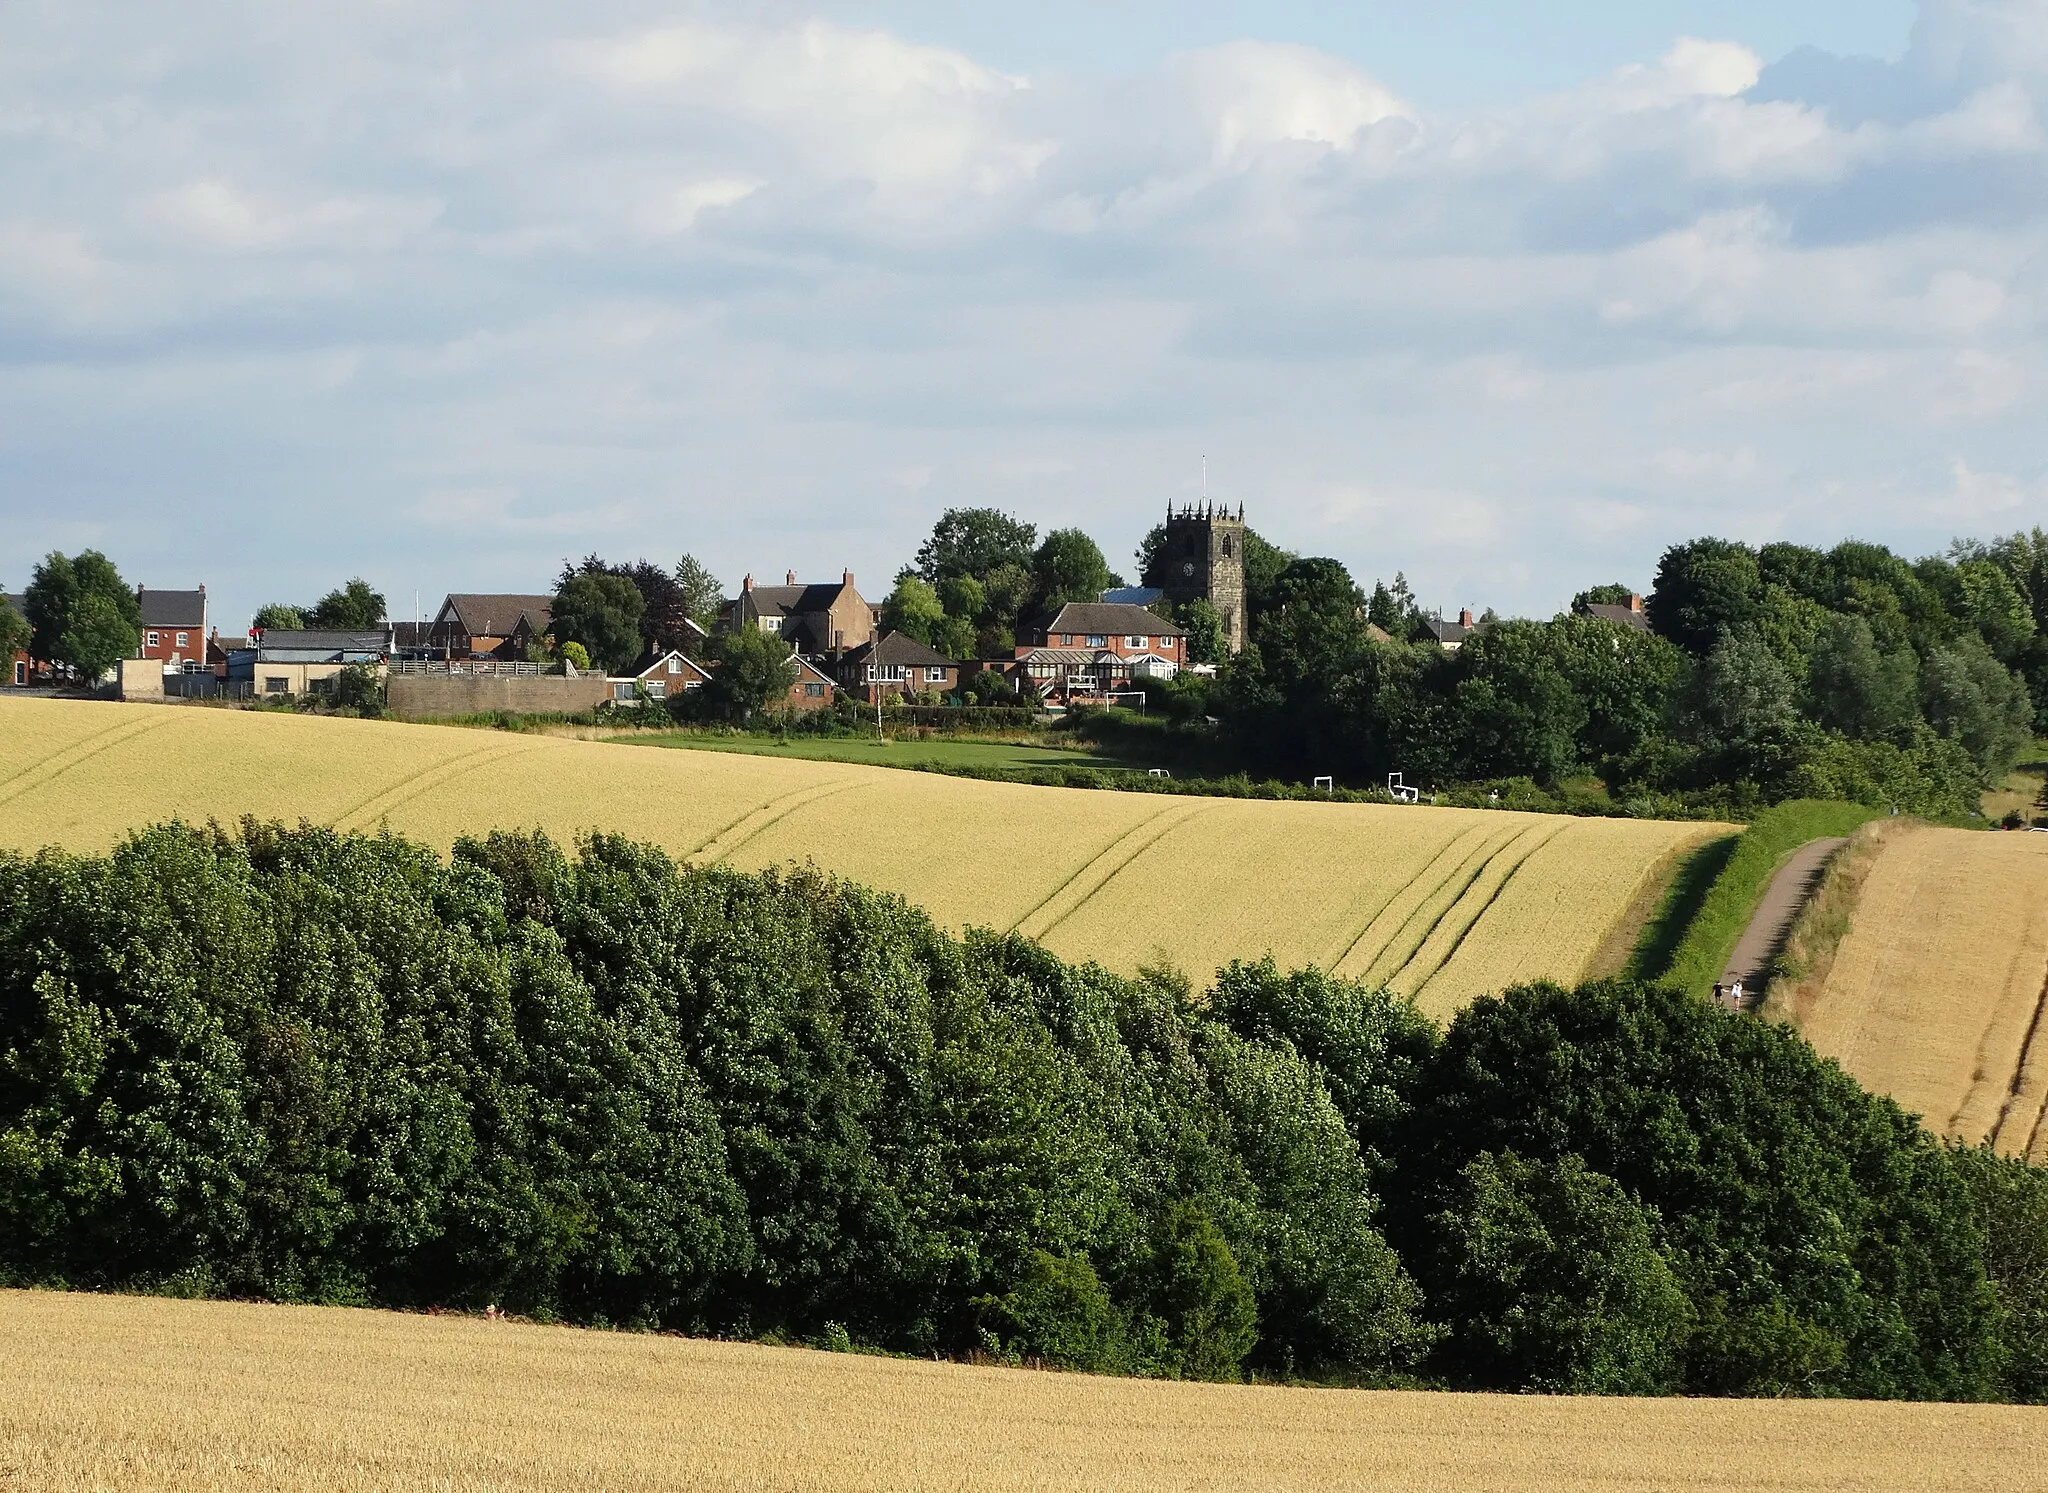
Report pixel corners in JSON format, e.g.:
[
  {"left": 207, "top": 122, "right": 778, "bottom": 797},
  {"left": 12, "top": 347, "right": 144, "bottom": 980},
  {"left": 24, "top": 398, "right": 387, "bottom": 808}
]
[{"left": 1634, "top": 799, "right": 1880, "bottom": 995}]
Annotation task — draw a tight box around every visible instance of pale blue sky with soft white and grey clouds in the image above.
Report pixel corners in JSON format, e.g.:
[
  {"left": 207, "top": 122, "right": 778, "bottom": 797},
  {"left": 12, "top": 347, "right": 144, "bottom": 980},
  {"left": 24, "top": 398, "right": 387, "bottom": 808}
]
[{"left": 0, "top": 0, "right": 2048, "bottom": 629}]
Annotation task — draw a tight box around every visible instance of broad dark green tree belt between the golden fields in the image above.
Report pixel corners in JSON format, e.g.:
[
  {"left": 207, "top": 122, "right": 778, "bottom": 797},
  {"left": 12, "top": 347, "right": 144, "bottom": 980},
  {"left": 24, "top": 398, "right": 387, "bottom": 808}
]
[{"left": 0, "top": 823, "right": 2048, "bottom": 1399}]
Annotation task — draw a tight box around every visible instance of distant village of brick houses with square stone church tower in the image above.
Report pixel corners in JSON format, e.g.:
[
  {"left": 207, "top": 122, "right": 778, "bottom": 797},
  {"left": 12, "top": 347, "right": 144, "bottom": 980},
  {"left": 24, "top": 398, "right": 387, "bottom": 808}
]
[{"left": 6, "top": 504, "right": 1613, "bottom": 713}]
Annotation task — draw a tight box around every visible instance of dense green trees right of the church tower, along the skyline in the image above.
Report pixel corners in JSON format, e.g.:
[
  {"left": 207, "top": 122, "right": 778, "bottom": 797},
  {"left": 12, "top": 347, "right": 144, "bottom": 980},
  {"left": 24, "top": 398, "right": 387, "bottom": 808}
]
[{"left": 1204, "top": 530, "right": 2048, "bottom": 815}]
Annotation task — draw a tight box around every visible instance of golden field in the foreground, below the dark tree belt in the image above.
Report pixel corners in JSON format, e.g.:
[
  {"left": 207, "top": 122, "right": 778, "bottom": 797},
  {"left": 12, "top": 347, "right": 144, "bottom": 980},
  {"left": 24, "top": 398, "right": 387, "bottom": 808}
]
[{"left": 0, "top": 1292, "right": 2048, "bottom": 1493}]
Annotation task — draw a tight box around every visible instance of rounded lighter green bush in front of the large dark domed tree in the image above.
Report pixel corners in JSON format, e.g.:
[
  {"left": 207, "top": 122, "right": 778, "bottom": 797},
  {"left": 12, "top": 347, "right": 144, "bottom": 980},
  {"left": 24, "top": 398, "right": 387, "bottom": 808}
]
[{"left": 1427, "top": 1151, "right": 1692, "bottom": 1395}]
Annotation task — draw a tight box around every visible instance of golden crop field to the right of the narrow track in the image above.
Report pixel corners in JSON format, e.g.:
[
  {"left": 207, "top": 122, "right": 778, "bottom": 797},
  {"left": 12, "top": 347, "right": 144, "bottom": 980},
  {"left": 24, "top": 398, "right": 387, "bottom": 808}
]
[{"left": 1800, "top": 825, "right": 2048, "bottom": 1161}]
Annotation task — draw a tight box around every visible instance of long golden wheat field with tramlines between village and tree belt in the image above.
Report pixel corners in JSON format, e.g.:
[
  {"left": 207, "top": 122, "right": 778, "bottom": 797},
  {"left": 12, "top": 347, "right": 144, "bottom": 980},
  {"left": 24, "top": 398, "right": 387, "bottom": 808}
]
[{"left": 0, "top": 700, "right": 1716, "bottom": 1016}]
